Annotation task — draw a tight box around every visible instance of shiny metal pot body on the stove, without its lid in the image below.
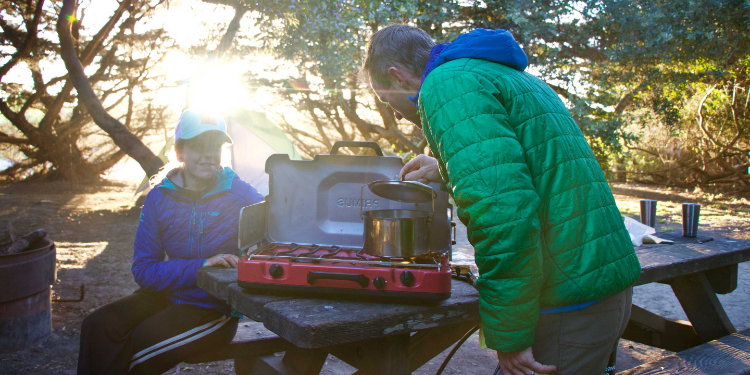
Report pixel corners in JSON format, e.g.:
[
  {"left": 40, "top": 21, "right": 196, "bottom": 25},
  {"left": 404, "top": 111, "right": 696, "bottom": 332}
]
[{"left": 364, "top": 209, "right": 431, "bottom": 258}]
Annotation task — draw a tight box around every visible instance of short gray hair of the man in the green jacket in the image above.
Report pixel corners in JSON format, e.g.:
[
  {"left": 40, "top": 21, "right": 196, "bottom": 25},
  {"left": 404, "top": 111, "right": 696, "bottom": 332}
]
[{"left": 362, "top": 25, "right": 435, "bottom": 86}]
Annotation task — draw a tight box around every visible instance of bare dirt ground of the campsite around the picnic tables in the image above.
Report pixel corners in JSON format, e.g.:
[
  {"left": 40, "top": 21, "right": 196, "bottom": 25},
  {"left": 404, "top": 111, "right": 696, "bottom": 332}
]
[{"left": 0, "top": 183, "right": 750, "bottom": 375}]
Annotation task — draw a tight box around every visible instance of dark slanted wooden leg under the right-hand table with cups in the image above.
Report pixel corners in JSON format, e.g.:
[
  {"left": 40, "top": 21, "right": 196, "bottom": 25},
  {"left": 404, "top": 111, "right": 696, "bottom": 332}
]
[{"left": 669, "top": 272, "right": 737, "bottom": 342}]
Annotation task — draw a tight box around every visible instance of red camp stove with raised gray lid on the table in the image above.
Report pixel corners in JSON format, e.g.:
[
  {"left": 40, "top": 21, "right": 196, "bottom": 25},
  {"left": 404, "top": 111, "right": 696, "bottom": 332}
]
[{"left": 237, "top": 141, "right": 455, "bottom": 302}]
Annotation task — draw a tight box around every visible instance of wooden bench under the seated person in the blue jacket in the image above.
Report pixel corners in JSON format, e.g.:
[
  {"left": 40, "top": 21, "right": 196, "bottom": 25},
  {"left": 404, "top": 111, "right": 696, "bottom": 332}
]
[{"left": 187, "top": 321, "right": 291, "bottom": 374}]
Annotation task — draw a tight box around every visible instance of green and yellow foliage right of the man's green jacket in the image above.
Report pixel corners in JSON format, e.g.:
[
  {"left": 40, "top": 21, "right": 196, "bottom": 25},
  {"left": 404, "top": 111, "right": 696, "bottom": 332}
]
[{"left": 473, "top": 0, "right": 750, "bottom": 191}]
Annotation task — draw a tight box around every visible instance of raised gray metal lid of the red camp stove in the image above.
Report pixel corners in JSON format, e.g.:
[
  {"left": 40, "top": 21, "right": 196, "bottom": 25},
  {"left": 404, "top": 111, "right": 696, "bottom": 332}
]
[{"left": 265, "top": 142, "right": 440, "bottom": 247}]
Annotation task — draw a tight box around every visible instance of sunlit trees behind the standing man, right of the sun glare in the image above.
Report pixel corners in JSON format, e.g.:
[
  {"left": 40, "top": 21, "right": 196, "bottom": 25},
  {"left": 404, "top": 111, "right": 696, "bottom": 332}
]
[{"left": 226, "top": 0, "right": 750, "bottom": 192}]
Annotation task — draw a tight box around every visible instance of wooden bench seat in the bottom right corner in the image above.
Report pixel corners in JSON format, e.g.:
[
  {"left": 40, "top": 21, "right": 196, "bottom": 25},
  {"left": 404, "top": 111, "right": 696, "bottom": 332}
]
[{"left": 617, "top": 329, "right": 750, "bottom": 375}]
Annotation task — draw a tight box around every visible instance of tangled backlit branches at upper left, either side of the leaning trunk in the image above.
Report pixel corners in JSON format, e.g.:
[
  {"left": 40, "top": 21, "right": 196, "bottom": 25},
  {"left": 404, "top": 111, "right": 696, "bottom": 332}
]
[{"left": 0, "top": 0, "right": 170, "bottom": 181}]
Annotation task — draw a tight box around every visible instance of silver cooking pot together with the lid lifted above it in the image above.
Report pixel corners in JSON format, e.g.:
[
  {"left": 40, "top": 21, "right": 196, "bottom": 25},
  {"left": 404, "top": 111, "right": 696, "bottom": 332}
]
[{"left": 360, "top": 180, "right": 437, "bottom": 258}]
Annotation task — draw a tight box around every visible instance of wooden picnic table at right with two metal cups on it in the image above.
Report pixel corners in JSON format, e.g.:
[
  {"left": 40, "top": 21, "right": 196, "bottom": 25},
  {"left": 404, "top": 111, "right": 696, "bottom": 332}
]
[{"left": 623, "top": 232, "right": 750, "bottom": 352}]
